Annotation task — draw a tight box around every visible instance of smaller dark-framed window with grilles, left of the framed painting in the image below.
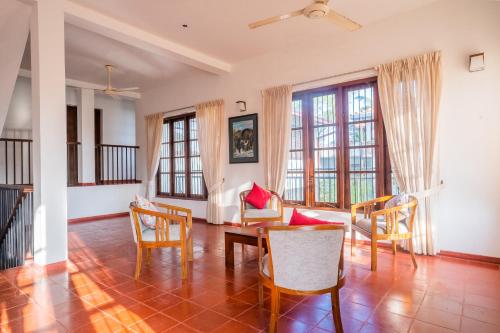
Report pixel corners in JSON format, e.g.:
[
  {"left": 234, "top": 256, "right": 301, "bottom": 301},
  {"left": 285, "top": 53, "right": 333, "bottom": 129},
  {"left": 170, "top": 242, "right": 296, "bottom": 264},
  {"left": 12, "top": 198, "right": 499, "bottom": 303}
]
[{"left": 157, "top": 114, "right": 207, "bottom": 199}]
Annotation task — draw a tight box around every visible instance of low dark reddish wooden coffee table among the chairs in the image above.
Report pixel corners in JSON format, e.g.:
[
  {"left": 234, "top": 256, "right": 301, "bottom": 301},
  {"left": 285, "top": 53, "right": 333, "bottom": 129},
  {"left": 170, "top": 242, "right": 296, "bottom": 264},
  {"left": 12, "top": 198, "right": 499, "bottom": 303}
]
[{"left": 224, "top": 222, "right": 283, "bottom": 267}]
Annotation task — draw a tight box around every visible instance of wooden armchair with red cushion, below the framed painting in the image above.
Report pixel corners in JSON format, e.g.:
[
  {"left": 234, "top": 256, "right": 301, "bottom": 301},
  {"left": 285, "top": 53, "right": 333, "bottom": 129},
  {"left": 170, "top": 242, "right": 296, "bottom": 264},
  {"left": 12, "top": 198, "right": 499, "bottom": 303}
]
[{"left": 240, "top": 190, "right": 283, "bottom": 227}]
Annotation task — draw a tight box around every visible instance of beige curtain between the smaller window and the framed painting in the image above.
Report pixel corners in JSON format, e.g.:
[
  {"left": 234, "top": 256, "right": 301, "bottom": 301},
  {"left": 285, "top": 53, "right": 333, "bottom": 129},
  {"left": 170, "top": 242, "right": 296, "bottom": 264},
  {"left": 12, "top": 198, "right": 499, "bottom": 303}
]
[{"left": 196, "top": 100, "right": 224, "bottom": 224}]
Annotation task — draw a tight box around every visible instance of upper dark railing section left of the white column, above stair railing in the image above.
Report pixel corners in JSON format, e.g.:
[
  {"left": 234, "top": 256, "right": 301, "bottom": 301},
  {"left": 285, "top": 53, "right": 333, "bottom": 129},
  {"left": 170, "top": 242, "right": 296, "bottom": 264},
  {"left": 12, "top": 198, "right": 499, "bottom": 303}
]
[{"left": 0, "top": 138, "right": 33, "bottom": 185}]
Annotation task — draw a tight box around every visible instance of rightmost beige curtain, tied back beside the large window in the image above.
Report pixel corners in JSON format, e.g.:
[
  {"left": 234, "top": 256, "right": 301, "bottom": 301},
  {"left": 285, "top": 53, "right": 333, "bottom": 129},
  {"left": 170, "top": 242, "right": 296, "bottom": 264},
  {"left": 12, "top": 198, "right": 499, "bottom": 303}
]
[{"left": 378, "top": 52, "right": 441, "bottom": 255}]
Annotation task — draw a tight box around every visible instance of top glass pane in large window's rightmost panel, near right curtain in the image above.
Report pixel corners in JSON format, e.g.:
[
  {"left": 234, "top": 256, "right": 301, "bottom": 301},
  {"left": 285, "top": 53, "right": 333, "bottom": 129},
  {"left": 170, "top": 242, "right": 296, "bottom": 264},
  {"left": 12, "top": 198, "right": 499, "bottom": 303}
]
[{"left": 347, "top": 86, "right": 375, "bottom": 122}]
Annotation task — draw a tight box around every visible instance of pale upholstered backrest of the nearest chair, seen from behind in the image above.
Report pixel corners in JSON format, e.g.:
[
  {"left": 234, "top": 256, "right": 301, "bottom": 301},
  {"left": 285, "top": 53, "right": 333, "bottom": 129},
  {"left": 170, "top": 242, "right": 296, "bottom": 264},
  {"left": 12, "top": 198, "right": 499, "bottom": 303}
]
[{"left": 266, "top": 225, "right": 345, "bottom": 291}]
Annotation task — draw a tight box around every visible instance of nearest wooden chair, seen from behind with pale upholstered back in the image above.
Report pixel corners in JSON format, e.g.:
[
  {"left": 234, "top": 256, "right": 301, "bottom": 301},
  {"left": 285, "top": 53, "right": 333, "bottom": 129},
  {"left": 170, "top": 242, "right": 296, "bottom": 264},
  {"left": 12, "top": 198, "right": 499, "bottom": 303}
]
[{"left": 257, "top": 225, "right": 345, "bottom": 333}]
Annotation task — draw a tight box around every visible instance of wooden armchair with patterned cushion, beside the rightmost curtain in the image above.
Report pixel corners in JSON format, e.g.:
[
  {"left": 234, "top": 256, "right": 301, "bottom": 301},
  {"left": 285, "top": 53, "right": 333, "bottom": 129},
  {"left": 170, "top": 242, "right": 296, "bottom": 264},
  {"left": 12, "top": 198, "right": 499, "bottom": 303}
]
[{"left": 351, "top": 195, "right": 418, "bottom": 271}]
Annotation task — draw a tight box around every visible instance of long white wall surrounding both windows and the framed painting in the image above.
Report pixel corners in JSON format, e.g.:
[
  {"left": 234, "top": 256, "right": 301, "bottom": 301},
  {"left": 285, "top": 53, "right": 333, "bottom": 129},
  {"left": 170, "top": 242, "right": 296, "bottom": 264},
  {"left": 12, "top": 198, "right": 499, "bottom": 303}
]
[{"left": 136, "top": 0, "right": 500, "bottom": 257}]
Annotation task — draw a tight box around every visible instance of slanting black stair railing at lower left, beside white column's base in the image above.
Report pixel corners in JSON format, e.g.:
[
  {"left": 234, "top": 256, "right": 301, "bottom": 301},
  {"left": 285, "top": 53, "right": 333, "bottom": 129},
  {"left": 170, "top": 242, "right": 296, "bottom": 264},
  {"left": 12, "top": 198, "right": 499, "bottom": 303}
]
[{"left": 0, "top": 185, "right": 34, "bottom": 270}]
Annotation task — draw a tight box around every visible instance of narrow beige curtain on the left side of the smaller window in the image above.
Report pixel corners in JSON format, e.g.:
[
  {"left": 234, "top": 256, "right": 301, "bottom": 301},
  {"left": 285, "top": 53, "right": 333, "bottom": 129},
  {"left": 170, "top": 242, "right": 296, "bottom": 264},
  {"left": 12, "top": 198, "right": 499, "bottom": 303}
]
[{"left": 146, "top": 113, "right": 163, "bottom": 199}]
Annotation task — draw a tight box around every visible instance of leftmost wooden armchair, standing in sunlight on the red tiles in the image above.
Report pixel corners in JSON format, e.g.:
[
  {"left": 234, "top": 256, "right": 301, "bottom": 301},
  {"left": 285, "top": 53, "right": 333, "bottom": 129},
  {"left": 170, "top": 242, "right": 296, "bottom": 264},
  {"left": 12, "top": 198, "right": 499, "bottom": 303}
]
[{"left": 130, "top": 202, "right": 193, "bottom": 280}]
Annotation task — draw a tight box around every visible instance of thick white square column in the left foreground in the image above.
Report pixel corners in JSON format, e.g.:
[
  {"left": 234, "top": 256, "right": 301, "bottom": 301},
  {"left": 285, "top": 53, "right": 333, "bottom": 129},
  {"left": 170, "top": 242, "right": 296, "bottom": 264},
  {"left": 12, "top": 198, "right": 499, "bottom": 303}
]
[{"left": 30, "top": 0, "right": 68, "bottom": 265}]
